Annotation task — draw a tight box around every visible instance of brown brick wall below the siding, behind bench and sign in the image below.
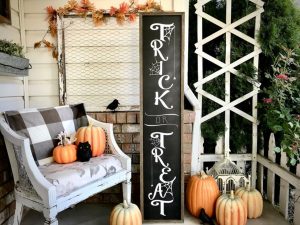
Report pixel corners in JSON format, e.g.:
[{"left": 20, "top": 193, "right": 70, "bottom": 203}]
[{"left": 0, "top": 111, "right": 194, "bottom": 222}]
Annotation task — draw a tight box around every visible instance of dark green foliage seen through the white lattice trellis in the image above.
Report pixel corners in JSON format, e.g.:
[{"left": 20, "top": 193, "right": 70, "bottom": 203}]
[{"left": 189, "top": 0, "right": 257, "bottom": 152}]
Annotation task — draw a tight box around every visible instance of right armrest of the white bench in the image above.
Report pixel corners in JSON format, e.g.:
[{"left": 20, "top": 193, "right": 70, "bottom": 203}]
[{"left": 87, "top": 116, "right": 131, "bottom": 171}]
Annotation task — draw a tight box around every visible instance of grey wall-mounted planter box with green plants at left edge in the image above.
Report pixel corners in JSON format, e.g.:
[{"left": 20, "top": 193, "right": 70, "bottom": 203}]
[{"left": 0, "top": 40, "right": 31, "bottom": 76}]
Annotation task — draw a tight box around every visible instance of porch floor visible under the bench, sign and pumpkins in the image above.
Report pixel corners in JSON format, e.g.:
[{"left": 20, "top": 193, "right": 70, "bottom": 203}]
[{"left": 21, "top": 202, "right": 289, "bottom": 225}]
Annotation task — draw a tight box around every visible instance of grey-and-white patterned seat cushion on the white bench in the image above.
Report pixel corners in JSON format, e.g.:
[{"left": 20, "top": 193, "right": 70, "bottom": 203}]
[{"left": 39, "top": 154, "right": 122, "bottom": 196}]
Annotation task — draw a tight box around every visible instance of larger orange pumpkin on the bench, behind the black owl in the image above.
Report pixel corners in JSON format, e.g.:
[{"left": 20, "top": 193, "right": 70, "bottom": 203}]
[{"left": 76, "top": 125, "right": 106, "bottom": 157}]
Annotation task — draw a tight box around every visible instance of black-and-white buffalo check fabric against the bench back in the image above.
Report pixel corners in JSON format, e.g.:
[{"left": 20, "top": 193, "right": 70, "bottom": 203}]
[{"left": 4, "top": 104, "right": 88, "bottom": 164}]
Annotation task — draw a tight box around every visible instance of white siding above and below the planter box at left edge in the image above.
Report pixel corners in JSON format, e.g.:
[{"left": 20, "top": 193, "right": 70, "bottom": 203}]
[{"left": 0, "top": 0, "right": 24, "bottom": 112}]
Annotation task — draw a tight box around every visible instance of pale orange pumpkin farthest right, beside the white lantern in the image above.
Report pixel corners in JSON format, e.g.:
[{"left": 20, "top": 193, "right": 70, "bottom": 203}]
[{"left": 235, "top": 184, "right": 263, "bottom": 219}]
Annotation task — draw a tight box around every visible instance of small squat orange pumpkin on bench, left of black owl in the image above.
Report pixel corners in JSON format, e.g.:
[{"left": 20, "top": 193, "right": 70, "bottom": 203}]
[{"left": 53, "top": 144, "right": 77, "bottom": 163}]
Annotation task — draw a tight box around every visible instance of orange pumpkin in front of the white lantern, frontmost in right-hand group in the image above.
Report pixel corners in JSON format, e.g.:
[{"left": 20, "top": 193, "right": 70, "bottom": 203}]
[{"left": 216, "top": 191, "right": 247, "bottom": 225}]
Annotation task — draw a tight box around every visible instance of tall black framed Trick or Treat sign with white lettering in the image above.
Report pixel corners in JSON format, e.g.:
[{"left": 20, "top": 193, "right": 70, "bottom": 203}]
[{"left": 140, "top": 13, "right": 183, "bottom": 222}]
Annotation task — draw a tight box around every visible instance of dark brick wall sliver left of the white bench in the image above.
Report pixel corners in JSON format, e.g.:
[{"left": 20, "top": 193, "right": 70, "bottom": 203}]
[{"left": 0, "top": 134, "right": 15, "bottom": 225}]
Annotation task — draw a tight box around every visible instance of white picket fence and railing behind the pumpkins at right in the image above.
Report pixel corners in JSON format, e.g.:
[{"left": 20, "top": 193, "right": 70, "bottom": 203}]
[{"left": 200, "top": 134, "right": 300, "bottom": 225}]
